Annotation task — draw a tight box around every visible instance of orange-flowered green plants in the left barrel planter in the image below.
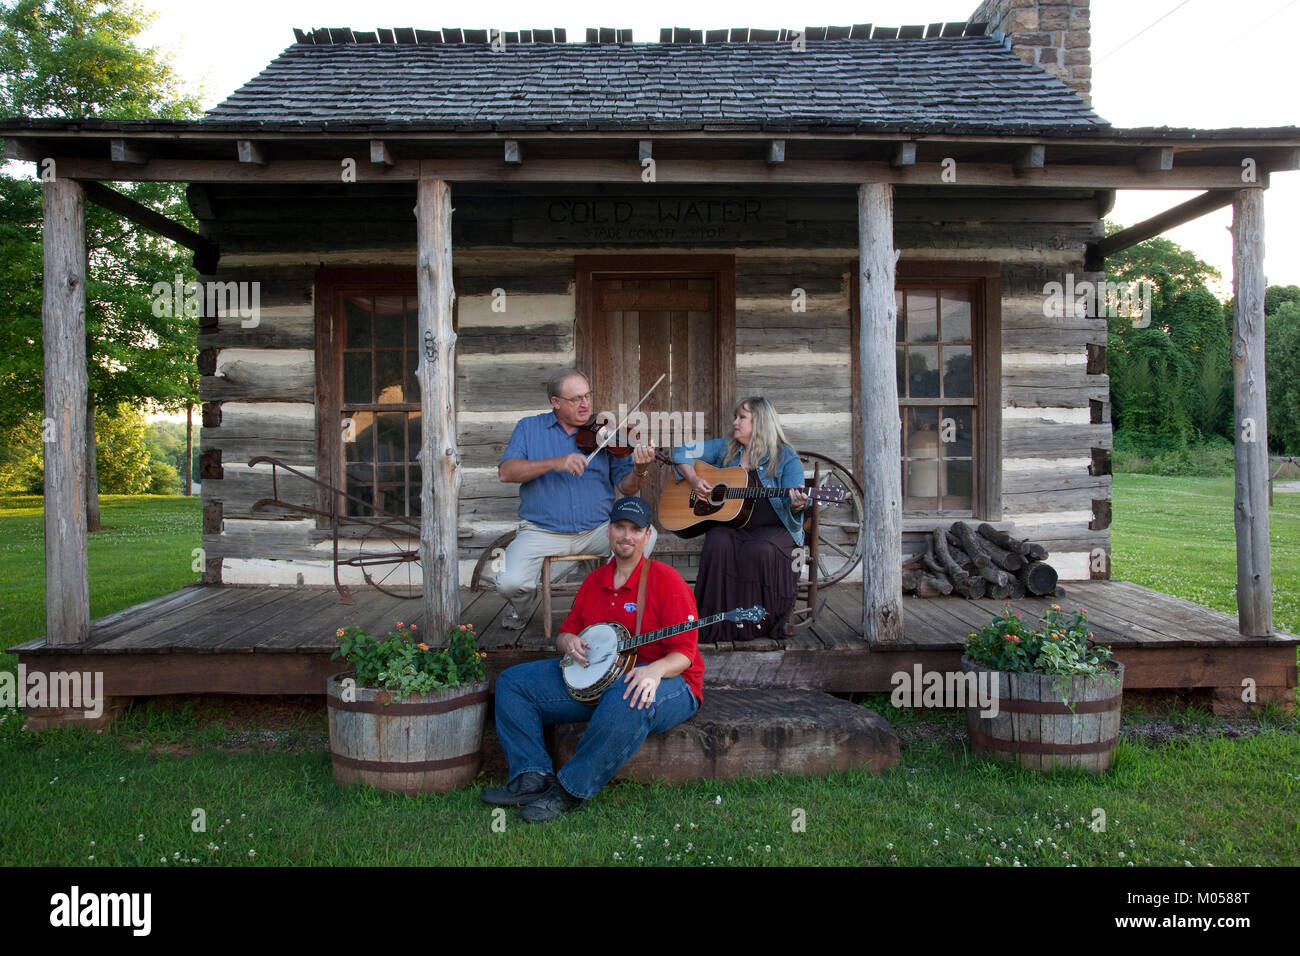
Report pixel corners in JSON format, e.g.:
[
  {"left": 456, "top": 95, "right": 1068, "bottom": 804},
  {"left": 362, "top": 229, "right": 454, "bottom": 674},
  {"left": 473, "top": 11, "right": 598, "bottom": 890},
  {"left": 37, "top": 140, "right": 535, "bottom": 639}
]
[{"left": 330, "top": 620, "right": 488, "bottom": 700}]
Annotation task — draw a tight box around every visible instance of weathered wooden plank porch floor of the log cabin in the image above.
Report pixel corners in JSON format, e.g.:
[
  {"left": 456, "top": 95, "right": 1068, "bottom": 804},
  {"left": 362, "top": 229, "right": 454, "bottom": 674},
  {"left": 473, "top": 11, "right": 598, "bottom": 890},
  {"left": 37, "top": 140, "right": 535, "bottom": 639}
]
[{"left": 10, "top": 581, "right": 1300, "bottom": 697}]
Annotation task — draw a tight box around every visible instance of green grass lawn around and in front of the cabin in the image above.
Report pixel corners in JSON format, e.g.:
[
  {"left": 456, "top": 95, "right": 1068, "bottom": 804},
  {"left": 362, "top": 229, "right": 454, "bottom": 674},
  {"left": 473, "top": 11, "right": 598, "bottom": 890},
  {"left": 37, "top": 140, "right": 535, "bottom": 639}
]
[{"left": 0, "top": 475, "right": 1300, "bottom": 866}]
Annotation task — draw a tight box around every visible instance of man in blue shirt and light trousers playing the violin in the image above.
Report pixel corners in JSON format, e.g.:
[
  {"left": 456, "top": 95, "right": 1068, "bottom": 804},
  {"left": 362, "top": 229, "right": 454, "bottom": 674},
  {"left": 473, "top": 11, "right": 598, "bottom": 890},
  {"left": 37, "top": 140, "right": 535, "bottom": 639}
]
[{"left": 497, "top": 368, "right": 655, "bottom": 630}]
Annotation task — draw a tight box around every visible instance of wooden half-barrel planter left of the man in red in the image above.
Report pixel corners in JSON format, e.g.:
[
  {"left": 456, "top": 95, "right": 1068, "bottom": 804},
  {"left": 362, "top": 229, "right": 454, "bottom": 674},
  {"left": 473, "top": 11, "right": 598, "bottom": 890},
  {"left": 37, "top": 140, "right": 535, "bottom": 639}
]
[{"left": 326, "top": 672, "right": 488, "bottom": 795}]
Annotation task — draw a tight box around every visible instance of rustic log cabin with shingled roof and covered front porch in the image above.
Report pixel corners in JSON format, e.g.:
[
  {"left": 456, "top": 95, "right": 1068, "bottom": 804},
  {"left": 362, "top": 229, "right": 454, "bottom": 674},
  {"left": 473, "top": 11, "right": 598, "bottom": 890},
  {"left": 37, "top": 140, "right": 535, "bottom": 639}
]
[{"left": 0, "top": 0, "right": 1300, "bottom": 723}]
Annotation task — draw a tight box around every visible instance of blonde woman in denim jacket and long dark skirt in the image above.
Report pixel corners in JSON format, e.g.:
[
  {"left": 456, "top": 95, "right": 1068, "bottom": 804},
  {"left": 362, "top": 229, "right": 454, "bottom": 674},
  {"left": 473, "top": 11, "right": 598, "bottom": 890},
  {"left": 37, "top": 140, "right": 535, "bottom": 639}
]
[{"left": 672, "top": 397, "right": 807, "bottom": 644}]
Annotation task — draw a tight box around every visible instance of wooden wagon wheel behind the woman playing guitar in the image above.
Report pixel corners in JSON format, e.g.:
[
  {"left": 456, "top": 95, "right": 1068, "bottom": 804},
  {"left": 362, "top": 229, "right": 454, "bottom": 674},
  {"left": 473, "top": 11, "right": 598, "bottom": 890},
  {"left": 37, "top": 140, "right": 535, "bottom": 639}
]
[{"left": 790, "top": 451, "right": 865, "bottom": 628}]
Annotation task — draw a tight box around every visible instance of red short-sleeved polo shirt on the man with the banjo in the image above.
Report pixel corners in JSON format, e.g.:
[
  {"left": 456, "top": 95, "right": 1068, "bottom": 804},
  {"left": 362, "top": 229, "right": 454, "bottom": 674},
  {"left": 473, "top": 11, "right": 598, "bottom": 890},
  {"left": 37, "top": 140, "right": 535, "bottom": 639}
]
[{"left": 560, "top": 558, "right": 705, "bottom": 701}]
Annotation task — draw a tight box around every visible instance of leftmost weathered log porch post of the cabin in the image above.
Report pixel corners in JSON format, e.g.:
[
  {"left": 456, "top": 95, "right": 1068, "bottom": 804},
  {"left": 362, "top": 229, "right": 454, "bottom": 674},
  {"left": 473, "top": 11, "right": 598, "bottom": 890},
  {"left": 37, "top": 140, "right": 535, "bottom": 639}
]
[{"left": 40, "top": 178, "right": 90, "bottom": 644}]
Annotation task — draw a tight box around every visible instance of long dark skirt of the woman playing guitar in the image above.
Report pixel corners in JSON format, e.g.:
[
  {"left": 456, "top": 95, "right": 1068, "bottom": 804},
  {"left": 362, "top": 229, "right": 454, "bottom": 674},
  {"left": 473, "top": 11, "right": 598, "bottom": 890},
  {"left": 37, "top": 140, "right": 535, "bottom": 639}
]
[{"left": 696, "top": 498, "right": 798, "bottom": 644}]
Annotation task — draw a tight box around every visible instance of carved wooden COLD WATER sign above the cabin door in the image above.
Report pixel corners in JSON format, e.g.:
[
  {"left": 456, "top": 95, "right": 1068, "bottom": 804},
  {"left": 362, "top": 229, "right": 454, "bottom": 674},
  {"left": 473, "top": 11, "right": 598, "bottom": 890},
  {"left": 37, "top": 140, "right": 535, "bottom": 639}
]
[{"left": 511, "top": 196, "right": 785, "bottom": 245}]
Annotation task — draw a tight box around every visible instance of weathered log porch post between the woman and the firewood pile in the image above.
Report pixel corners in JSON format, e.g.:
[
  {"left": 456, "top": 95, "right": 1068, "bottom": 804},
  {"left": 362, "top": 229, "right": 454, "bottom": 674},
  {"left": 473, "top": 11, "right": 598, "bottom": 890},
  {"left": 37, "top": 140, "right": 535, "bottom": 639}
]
[{"left": 858, "top": 183, "right": 902, "bottom": 643}]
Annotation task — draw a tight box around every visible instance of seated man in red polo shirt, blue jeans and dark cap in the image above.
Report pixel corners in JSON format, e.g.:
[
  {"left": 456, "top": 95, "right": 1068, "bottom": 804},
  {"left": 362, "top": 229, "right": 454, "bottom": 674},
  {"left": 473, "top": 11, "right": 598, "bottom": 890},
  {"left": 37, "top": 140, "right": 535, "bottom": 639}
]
[{"left": 482, "top": 497, "right": 705, "bottom": 823}]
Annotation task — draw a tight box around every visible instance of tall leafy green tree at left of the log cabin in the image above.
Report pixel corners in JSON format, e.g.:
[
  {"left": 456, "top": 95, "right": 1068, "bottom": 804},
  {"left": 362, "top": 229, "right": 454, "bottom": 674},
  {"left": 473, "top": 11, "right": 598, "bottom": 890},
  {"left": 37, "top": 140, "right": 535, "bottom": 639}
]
[{"left": 0, "top": 0, "right": 199, "bottom": 529}]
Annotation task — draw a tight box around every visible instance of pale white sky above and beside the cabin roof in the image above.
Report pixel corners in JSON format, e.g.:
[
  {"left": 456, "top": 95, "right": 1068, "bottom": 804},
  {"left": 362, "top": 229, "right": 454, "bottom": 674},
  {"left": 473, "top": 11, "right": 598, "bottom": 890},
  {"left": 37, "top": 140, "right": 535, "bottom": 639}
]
[{"left": 126, "top": 0, "right": 1300, "bottom": 294}]
